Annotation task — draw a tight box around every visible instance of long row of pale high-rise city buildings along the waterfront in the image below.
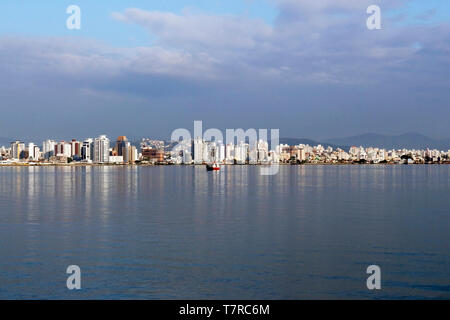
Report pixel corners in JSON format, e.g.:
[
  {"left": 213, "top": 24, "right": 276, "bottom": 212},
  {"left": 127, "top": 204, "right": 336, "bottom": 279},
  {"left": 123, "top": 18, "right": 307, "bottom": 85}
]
[{"left": 0, "top": 132, "right": 450, "bottom": 168}]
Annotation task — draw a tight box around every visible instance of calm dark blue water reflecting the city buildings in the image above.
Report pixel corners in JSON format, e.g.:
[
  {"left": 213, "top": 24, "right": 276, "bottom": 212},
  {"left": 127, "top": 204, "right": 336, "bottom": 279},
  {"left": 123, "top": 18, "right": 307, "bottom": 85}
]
[{"left": 0, "top": 165, "right": 450, "bottom": 299}]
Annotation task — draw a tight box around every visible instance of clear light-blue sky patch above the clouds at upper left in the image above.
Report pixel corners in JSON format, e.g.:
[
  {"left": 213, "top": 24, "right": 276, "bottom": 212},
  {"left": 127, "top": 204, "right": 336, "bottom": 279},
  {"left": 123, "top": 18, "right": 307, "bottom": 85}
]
[{"left": 0, "top": 0, "right": 277, "bottom": 46}]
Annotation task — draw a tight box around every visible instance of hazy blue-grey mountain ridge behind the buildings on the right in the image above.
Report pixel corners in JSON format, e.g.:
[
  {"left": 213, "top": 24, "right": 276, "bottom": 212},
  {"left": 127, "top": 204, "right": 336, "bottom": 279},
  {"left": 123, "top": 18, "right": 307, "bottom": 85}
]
[{"left": 326, "top": 132, "right": 450, "bottom": 150}]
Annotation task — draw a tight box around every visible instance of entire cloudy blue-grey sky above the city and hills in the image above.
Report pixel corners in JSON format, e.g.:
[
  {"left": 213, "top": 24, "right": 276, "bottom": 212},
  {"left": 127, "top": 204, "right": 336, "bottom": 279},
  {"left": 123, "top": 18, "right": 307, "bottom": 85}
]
[{"left": 0, "top": 0, "right": 450, "bottom": 140}]
